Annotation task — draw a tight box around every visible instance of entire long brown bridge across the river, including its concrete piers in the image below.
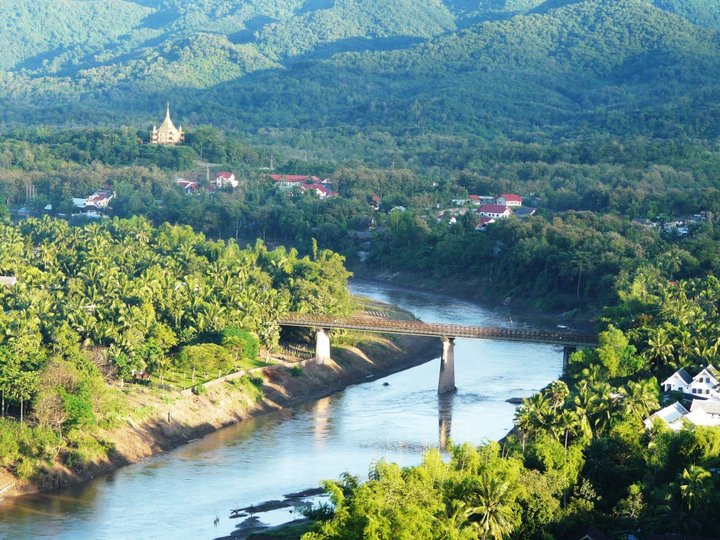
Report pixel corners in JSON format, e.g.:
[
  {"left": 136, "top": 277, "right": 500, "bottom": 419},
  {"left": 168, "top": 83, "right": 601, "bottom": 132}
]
[{"left": 279, "top": 313, "right": 597, "bottom": 394}]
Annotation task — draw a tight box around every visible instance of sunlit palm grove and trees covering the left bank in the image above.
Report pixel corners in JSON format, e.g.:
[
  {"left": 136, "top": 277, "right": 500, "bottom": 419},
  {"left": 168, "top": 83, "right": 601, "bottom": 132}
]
[{"left": 0, "top": 216, "right": 351, "bottom": 486}]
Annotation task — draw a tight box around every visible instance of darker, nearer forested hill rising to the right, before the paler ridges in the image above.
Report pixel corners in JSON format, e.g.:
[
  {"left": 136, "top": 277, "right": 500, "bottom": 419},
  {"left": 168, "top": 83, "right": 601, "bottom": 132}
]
[{"left": 176, "top": 0, "right": 720, "bottom": 141}]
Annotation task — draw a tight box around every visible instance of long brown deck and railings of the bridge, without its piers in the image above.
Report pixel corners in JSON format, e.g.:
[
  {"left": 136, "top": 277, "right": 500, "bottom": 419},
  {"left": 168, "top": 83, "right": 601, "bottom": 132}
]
[{"left": 280, "top": 313, "right": 597, "bottom": 346}]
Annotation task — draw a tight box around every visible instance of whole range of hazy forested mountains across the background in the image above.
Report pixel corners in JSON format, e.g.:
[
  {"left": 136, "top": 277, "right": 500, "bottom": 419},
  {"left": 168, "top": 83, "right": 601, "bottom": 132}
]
[{"left": 0, "top": 0, "right": 720, "bottom": 152}]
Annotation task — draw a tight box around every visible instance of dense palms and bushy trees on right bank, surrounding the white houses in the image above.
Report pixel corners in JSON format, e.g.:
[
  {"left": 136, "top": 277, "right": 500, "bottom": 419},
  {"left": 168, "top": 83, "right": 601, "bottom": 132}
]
[{"left": 294, "top": 272, "right": 720, "bottom": 540}]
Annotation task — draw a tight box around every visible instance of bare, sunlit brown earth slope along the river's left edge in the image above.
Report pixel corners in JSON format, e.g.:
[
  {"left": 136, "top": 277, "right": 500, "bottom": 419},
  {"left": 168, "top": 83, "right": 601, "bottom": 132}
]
[{"left": 0, "top": 330, "right": 440, "bottom": 498}]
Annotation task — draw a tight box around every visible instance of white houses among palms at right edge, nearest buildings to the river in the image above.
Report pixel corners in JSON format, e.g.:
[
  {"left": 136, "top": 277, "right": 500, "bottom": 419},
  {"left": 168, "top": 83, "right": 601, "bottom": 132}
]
[{"left": 645, "top": 364, "right": 720, "bottom": 431}]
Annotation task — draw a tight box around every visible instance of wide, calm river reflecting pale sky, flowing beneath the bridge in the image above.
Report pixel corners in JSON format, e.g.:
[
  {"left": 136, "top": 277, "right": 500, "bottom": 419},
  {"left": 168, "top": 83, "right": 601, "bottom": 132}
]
[{"left": 0, "top": 282, "right": 562, "bottom": 540}]
